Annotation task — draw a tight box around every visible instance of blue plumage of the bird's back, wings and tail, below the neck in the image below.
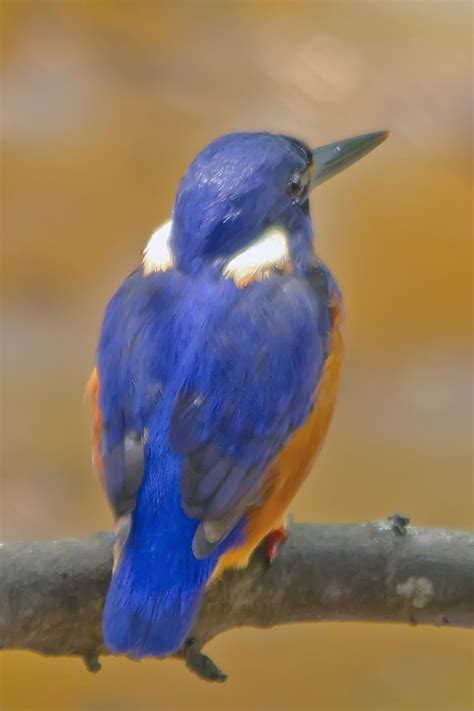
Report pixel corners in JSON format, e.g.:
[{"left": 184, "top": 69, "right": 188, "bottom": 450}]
[{"left": 98, "top": 262, "right": 323, "bottom": 656}]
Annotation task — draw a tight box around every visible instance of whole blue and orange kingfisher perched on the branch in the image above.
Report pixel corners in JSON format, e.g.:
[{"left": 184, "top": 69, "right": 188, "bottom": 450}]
[{"left": 89, "top": 131, "right": 387, "bottom": 658}]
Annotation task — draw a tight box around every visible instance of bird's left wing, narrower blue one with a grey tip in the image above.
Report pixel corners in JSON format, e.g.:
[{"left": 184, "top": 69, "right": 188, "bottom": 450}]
[{"left": 89, "top": 269, "right": 183, "bottom": 518}]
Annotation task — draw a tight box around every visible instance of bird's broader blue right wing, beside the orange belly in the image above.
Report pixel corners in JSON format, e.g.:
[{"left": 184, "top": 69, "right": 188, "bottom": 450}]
[{"left": 170, "top": 275, "right": 327, "bottom": 557}]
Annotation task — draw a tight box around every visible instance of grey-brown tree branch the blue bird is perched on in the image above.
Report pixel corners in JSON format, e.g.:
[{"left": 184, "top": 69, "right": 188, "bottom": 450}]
[{"left": 0, "top": 516, "right": 474, "bottom": 681}]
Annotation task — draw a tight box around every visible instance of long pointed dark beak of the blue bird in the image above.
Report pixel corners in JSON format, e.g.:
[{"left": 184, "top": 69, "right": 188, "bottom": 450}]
[{"left": 310, "top": 131, "right": 388, "bottom": 189}]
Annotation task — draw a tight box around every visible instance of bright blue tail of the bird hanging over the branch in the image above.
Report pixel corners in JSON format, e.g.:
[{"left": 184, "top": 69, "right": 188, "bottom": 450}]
[{"left": 103, "top": 447, "right": 218, "bottom": 658}]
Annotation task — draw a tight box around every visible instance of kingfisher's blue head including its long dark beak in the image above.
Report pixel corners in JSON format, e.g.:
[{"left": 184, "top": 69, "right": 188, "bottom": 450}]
[{"left": 143, "top": 132, "right": 387, "bottom": 282}]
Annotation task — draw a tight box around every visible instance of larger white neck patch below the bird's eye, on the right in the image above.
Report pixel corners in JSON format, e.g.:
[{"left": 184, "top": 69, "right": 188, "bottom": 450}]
[{"left": 223, "top": 226, "right": 291, "bottom": 287}]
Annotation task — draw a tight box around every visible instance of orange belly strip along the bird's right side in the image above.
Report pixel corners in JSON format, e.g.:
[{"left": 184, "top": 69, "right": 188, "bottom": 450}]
[{"left": 213, "top": 296, "right": 342, "bottom": 578}]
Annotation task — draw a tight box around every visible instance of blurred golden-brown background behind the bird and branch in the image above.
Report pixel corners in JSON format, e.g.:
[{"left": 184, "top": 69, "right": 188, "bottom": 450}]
[{"left": 1, "top": 0, "right": 473, "bottom": 711}]
